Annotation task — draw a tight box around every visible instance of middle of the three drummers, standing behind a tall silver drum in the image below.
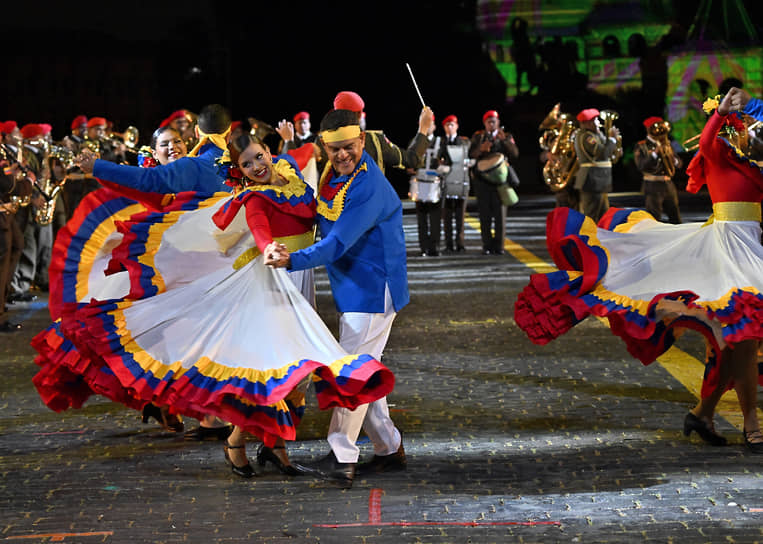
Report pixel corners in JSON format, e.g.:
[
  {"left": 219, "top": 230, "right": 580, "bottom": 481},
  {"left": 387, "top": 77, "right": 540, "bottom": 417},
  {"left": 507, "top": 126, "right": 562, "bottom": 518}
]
[{"left": 439, "top": 115, "right": 471, "bottom": 252}]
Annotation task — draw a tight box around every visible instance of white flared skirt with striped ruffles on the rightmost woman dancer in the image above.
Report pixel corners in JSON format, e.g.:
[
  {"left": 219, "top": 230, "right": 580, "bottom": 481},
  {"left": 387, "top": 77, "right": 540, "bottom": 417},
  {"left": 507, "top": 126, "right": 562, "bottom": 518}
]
[{"left": 514, "top": 208, "right": 763, "bottom": 395}]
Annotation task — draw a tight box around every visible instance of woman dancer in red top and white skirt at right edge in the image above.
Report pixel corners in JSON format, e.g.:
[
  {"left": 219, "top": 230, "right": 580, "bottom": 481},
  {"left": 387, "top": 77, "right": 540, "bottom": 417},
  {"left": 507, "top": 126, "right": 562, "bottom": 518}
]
[{"left": 514, "top": 92, "right": 763, "bottom": 453}]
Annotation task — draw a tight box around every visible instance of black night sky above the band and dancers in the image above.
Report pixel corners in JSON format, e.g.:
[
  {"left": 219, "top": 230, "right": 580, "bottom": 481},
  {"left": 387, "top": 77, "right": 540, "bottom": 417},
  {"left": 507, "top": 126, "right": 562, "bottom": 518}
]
[{"left": 0, "top": 0, "right": 763, "bottom": 196}]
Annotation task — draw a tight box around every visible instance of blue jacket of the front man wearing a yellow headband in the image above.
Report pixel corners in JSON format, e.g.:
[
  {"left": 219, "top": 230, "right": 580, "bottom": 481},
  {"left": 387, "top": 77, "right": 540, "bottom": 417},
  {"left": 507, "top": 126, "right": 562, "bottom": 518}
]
[{"left": 291, "top": 151, "right": 410, "bottom": 313}]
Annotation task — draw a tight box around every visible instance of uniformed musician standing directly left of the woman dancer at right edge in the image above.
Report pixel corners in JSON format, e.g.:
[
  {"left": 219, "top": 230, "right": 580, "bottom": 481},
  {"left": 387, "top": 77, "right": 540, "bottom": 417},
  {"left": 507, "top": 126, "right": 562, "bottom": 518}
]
[{"left": 633, "top": 117, "right": 682, "bottom": 225}]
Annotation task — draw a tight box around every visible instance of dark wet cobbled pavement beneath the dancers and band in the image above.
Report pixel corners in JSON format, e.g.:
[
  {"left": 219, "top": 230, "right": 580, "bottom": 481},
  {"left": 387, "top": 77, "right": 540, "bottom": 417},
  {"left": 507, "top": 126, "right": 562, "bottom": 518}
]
[{"left": 0, "top": 195, "right": 763, "bottom": 544}]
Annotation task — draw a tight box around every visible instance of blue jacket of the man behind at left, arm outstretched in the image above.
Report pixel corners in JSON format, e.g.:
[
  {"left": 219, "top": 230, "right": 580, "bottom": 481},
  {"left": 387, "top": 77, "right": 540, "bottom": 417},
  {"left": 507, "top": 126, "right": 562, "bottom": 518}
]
[{"left": 93, "top": 143, "right": 231, "bottom": 194}]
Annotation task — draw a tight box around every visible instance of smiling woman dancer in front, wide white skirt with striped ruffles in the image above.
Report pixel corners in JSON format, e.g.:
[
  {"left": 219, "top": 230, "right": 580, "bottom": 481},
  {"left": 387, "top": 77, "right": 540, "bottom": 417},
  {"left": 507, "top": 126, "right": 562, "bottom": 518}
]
[{"left": 30, "top": 132, "right": 394, "bottom": 477}]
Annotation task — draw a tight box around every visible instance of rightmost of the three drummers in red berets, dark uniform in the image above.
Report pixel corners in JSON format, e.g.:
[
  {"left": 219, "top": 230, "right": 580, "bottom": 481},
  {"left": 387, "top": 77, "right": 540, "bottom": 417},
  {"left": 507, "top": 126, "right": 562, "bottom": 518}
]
[{"left": 469, "top": 110, "right": 519, "bottom": 255}]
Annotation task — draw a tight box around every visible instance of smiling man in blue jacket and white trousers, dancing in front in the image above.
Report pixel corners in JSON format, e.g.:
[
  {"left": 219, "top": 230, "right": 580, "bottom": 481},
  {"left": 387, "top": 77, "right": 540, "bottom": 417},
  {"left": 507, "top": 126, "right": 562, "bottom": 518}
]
[{"left": 265, "top": 109, "right": 409, "bottom": 487}]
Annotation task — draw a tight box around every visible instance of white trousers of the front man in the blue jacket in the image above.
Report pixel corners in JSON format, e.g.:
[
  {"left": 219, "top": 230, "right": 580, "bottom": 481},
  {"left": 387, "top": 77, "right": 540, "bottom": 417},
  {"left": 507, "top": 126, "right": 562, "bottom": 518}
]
[{"left": 328, "top": 288, "right": 401, "bottom": 463}]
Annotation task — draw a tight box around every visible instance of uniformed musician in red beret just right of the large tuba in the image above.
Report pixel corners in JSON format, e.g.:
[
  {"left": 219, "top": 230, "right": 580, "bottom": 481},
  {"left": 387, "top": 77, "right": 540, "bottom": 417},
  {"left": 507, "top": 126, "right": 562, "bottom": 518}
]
[{"left": 575, "top": 108, "right": 620, "bottom": 222}]
